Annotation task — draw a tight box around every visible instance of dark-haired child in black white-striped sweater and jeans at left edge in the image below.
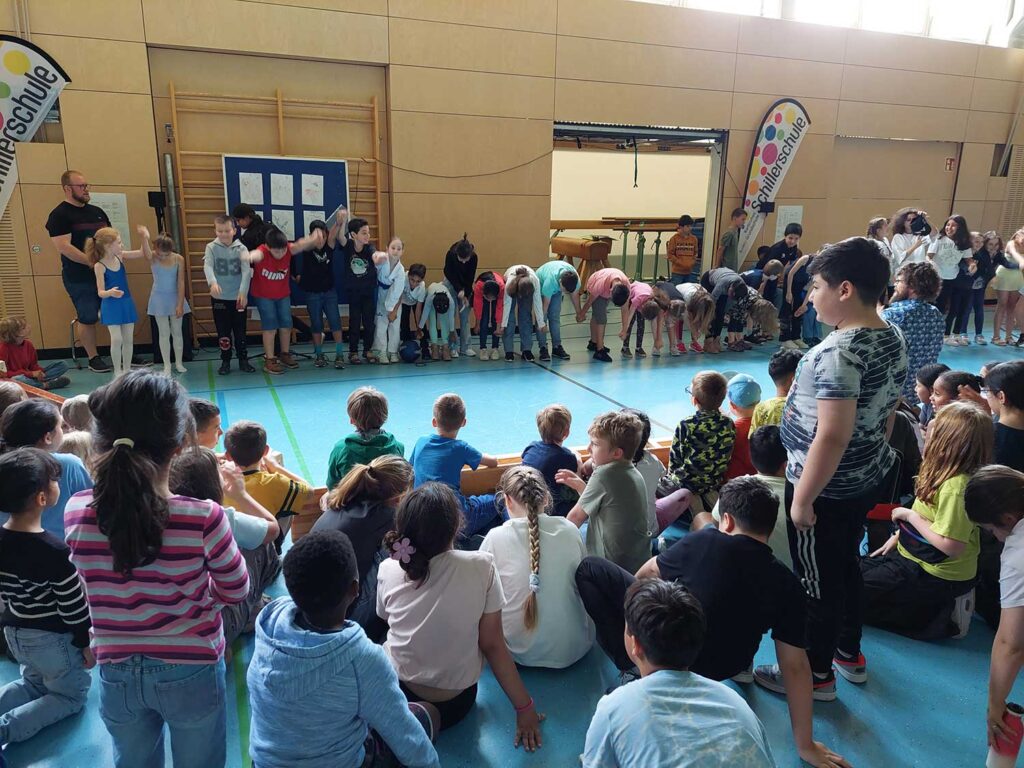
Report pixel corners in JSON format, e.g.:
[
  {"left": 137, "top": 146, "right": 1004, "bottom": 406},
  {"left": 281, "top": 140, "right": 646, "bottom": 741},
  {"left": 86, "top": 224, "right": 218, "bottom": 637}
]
[{"left": 0, "top": 447, "right": 96, "bottom": 743}]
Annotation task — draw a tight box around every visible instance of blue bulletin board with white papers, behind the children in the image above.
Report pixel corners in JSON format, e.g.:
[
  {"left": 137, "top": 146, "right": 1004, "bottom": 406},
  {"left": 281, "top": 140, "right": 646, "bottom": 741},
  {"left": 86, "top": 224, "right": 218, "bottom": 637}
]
[{"left": 221, "top": 155, "right": 350, "bottom": 304}]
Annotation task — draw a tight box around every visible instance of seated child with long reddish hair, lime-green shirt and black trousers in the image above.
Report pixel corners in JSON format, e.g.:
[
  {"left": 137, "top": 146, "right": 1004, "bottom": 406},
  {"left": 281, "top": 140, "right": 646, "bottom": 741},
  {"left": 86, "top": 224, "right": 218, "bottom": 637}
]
[{"left": 860, "top": 402, "right": 993, "bottom": 643}]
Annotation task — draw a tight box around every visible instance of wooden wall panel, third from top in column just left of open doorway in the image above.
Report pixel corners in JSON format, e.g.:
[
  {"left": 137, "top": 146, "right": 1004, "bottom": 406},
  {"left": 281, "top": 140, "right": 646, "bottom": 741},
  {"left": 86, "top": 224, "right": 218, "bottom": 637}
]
[{"left": 389, "top": 65, "right": 555, "bottom": 120}]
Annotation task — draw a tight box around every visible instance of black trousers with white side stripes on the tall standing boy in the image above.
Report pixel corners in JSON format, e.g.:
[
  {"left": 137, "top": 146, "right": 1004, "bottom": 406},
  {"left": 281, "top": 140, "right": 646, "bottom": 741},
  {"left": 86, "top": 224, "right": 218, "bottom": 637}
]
[{"left": 785, "top": 482, "right": 878, "bottom": 675}]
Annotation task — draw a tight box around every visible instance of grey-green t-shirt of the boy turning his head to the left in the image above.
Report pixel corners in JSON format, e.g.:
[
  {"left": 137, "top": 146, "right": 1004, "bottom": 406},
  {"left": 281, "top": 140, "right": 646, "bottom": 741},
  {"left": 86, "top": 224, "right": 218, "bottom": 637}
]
[{"left": 580, "top": 460, "right": 650, "bottom": 573}]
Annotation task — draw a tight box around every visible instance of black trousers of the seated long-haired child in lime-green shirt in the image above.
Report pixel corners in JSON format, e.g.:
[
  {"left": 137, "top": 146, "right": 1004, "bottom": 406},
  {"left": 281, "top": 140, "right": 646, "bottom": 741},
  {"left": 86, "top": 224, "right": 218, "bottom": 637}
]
[{"left": 860, "top": 550, "right": 974, "bottom": 638}]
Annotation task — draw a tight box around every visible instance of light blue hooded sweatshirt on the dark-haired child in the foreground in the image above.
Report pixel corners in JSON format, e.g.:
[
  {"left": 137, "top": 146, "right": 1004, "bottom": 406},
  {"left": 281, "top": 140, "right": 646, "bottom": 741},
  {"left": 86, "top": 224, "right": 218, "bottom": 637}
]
[{"left": 247, "top": 597, "right": 440, "bottom": 768}]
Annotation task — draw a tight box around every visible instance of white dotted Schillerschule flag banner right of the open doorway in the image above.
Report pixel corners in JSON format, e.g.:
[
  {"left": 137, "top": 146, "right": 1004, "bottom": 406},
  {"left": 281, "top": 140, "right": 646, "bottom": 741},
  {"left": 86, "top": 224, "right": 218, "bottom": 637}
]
[{"left": 738, "top": 98, "right": 811, "bottom": 264}]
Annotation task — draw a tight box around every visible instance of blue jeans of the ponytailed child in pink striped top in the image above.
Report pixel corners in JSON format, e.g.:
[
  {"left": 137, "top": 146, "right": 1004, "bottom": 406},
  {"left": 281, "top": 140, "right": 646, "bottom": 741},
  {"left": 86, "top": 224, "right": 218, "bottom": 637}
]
[{"left": 99, "top": 654, "right": 227, "bottom": 768}]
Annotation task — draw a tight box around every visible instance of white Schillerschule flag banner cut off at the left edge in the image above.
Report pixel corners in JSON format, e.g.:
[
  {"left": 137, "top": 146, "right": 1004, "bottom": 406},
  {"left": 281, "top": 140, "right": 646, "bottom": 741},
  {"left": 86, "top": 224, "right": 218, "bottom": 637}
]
[{"left": 0, "top": 35, "right": 71, "bottom": 222}]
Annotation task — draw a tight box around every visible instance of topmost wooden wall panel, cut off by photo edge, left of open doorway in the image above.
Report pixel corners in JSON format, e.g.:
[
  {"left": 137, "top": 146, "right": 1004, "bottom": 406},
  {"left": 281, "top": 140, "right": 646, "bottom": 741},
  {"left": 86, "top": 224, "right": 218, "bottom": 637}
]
[{"left": 388, "top": 0, "right": 556, "bottom": 33}]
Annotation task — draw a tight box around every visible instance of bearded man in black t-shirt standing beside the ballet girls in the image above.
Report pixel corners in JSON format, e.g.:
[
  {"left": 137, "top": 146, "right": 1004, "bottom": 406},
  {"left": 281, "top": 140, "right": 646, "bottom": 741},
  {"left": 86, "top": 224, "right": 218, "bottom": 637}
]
[{"left": 46, "top": 171, "right": 112, "bottom": 373}]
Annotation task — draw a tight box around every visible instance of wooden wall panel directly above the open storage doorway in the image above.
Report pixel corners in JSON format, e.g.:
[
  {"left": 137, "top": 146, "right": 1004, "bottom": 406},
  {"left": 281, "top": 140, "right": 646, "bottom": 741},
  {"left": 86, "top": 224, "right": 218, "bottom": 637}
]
[{"left": 555, "top": 80, "right": 731, "bottom": 128}]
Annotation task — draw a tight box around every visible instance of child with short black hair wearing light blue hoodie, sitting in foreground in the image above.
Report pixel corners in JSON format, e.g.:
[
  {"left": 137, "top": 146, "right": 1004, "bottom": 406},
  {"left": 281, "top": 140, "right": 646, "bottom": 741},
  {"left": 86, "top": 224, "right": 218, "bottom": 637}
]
[{"left": 247, "top": 530, "right": 440, "bottom": 768}]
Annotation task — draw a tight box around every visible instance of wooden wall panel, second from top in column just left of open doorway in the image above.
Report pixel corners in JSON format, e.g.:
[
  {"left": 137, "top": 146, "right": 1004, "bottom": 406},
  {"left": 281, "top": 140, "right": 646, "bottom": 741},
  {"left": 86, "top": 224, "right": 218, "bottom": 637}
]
[{"left": 389, "top": 18, "right": 555, "bottom": 77}]
